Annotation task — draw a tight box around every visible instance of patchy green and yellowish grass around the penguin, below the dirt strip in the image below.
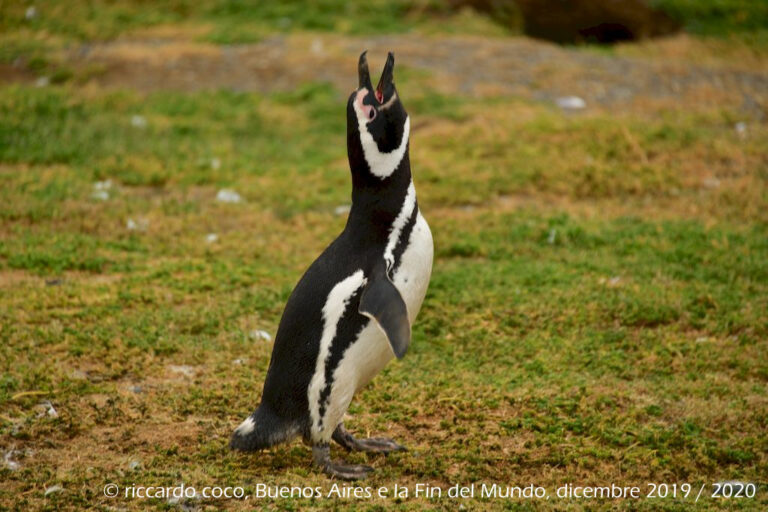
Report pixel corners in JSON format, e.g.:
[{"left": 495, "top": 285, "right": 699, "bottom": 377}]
[{"left": 0, "top": 2, "right": 768, "bottom": 510}]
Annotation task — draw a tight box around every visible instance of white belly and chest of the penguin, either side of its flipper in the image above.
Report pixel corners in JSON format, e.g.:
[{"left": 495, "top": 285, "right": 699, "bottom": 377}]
[{"left": 317, "top": 213, "right": 433, "bottom": 439}]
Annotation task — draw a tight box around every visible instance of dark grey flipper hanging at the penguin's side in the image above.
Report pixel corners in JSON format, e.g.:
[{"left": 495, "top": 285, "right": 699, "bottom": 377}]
[{"left": 358, "top": 270, "right": 411, "bottom": 359}]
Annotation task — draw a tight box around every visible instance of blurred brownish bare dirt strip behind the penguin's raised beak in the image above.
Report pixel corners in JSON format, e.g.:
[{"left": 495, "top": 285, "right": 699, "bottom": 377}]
[{"left": 7, "top": 34, "right": 768, "bottom": 118}]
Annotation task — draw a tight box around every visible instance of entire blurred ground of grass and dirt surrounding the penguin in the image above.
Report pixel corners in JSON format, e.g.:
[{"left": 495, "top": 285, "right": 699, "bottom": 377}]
[{"left": 0, "top": 0, "right": 768, "bottom": 509}]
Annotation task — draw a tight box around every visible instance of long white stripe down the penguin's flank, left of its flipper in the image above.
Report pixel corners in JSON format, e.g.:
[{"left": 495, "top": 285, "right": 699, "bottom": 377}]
[{"left": 307, "top": 270, "right": 366, "bottom": 433}]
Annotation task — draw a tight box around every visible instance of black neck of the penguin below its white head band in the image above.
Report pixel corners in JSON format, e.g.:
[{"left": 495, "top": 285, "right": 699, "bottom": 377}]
[{"left": 347, "top": 150, "right": 415, "bottom": 237}]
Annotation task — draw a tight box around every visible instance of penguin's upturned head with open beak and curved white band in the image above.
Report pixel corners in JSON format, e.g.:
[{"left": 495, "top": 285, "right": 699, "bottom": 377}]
[{"left": 347, "top": 51, "right": 410, "bottom": 179}]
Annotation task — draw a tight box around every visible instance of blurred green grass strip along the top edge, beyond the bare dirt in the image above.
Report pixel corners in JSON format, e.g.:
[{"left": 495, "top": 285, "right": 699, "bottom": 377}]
[{"left": 0, "top": 0, "right": 768, "bottom": 51}]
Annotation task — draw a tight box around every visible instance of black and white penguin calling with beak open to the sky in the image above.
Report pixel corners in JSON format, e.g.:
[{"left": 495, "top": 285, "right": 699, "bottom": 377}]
[{"left": 230, "top": 52, "right": 433, "bottom": 480}]
